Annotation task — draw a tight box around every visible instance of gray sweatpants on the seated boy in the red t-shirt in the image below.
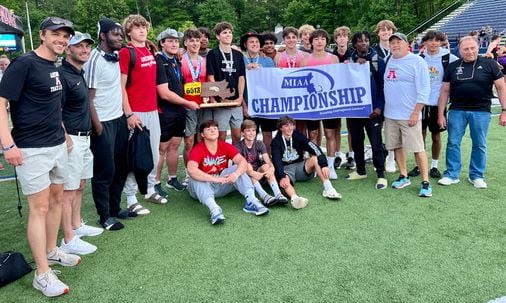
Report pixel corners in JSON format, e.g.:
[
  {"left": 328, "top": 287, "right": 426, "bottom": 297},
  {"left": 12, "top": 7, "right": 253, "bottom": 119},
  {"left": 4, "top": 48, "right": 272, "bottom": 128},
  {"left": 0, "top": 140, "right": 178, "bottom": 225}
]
[{"left": 188, "top": 165, "right": 255, "bottom": 211}]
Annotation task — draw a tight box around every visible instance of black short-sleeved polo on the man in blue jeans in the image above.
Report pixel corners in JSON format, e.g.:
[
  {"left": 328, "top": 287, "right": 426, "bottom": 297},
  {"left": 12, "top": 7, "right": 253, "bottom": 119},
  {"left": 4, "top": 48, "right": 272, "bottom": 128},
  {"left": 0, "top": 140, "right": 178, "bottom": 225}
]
[{"left": 443, "top": 57, "right": 503, "bottom": 111}]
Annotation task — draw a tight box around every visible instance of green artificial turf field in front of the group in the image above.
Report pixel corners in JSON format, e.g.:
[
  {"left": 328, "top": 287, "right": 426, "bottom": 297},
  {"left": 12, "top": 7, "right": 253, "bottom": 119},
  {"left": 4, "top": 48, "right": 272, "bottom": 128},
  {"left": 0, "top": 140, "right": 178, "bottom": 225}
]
[{"left": 0, "top": 117, "right": 506, "bottom": 302}]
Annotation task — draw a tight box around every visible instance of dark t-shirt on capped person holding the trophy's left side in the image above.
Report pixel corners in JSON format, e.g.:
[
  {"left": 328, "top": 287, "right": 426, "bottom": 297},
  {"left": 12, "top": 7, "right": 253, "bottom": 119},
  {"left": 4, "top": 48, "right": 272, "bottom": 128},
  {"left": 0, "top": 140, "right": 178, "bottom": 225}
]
[{"left": 155, "top": 54, "right": 185, "bottom": 115}]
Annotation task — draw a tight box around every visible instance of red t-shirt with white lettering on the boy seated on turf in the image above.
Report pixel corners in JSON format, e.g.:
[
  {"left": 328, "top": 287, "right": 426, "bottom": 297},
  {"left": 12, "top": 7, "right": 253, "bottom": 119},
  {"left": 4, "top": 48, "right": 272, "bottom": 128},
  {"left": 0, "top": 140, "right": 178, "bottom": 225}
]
[{"left": 189, "top": 140, "right": 239, "bottom": 175}]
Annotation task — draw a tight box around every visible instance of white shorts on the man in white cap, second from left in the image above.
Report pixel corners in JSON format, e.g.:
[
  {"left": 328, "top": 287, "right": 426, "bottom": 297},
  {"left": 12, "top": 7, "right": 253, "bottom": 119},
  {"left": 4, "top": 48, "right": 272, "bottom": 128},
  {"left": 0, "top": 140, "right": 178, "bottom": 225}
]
[{"left": 63, "top": 135, "right": 93, "bottom": 190}]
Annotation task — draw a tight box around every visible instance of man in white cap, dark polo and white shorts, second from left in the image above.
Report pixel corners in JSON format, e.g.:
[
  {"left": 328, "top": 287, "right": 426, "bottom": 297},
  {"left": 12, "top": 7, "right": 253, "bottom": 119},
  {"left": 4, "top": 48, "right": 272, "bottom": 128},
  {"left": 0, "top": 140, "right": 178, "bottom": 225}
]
[{"left": 58, "top": 31, "right": 104, "bottom": 255}]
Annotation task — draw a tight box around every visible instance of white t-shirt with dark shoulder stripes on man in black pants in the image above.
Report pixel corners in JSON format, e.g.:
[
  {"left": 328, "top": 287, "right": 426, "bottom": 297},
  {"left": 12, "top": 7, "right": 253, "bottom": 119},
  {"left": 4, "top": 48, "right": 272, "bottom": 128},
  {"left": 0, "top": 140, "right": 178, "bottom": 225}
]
[{"left": 83, "top": 49, "right": 123, "bottom": 122}]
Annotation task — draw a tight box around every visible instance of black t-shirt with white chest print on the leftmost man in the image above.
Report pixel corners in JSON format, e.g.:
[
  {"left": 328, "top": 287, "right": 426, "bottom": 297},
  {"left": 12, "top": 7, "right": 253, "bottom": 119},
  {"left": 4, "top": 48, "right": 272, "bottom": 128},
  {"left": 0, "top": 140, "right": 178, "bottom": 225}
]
[{"left": 0, "top": 51, "right": 65, "bottom": 148}]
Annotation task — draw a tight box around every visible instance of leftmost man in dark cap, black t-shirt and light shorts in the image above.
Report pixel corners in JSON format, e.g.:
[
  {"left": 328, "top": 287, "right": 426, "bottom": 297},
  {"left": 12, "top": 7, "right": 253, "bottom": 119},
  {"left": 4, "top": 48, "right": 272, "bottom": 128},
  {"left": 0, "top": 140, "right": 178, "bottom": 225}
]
[{"left": 0, "top": 17, "right": 81, "bottom": 297}]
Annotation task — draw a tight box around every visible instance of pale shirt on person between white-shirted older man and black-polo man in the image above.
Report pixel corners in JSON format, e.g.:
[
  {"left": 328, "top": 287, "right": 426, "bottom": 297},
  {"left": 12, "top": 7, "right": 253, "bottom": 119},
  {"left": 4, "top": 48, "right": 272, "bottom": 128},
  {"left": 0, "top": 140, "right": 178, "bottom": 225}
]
[{"left": 423, "top": 47, "right": 459, "bottom": 106}]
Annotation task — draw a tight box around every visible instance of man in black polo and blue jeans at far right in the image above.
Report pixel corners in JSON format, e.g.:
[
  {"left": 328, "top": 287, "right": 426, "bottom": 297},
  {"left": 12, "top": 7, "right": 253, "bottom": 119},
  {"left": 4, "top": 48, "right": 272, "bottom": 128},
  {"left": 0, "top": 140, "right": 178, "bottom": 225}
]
[{"left": 438, "top": 36, "right": 506, "bottom": 189}]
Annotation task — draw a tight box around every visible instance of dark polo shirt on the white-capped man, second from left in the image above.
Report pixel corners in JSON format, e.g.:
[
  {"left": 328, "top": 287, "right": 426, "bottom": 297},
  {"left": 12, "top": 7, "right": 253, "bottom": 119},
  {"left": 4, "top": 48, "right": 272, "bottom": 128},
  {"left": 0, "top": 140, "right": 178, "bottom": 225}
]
[{"left": 57, "top": 59, "right": 91, "bottom": 134}]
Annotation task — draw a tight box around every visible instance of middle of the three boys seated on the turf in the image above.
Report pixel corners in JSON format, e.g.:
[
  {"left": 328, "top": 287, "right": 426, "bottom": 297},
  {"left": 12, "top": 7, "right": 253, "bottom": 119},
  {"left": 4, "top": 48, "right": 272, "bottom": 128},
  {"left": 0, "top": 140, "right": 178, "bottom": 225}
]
[{"left": 234, "top": 120, "right": 288, "bottom": 206}]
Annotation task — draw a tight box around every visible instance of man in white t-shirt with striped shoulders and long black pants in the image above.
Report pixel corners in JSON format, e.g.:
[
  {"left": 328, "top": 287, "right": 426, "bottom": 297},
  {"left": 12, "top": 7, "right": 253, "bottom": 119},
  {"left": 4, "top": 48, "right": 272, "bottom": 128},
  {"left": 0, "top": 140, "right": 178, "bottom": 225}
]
[{"left": 84, "top": 19, "right": 131, "bottom": 231}]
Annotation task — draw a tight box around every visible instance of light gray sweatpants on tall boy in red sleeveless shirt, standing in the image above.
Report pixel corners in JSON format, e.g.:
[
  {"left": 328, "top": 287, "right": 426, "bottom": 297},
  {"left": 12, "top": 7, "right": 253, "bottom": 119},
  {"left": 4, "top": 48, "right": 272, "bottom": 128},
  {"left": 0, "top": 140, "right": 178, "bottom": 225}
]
[{"left": 123, "top": 111, "right": 161, "bottom": 196}]
